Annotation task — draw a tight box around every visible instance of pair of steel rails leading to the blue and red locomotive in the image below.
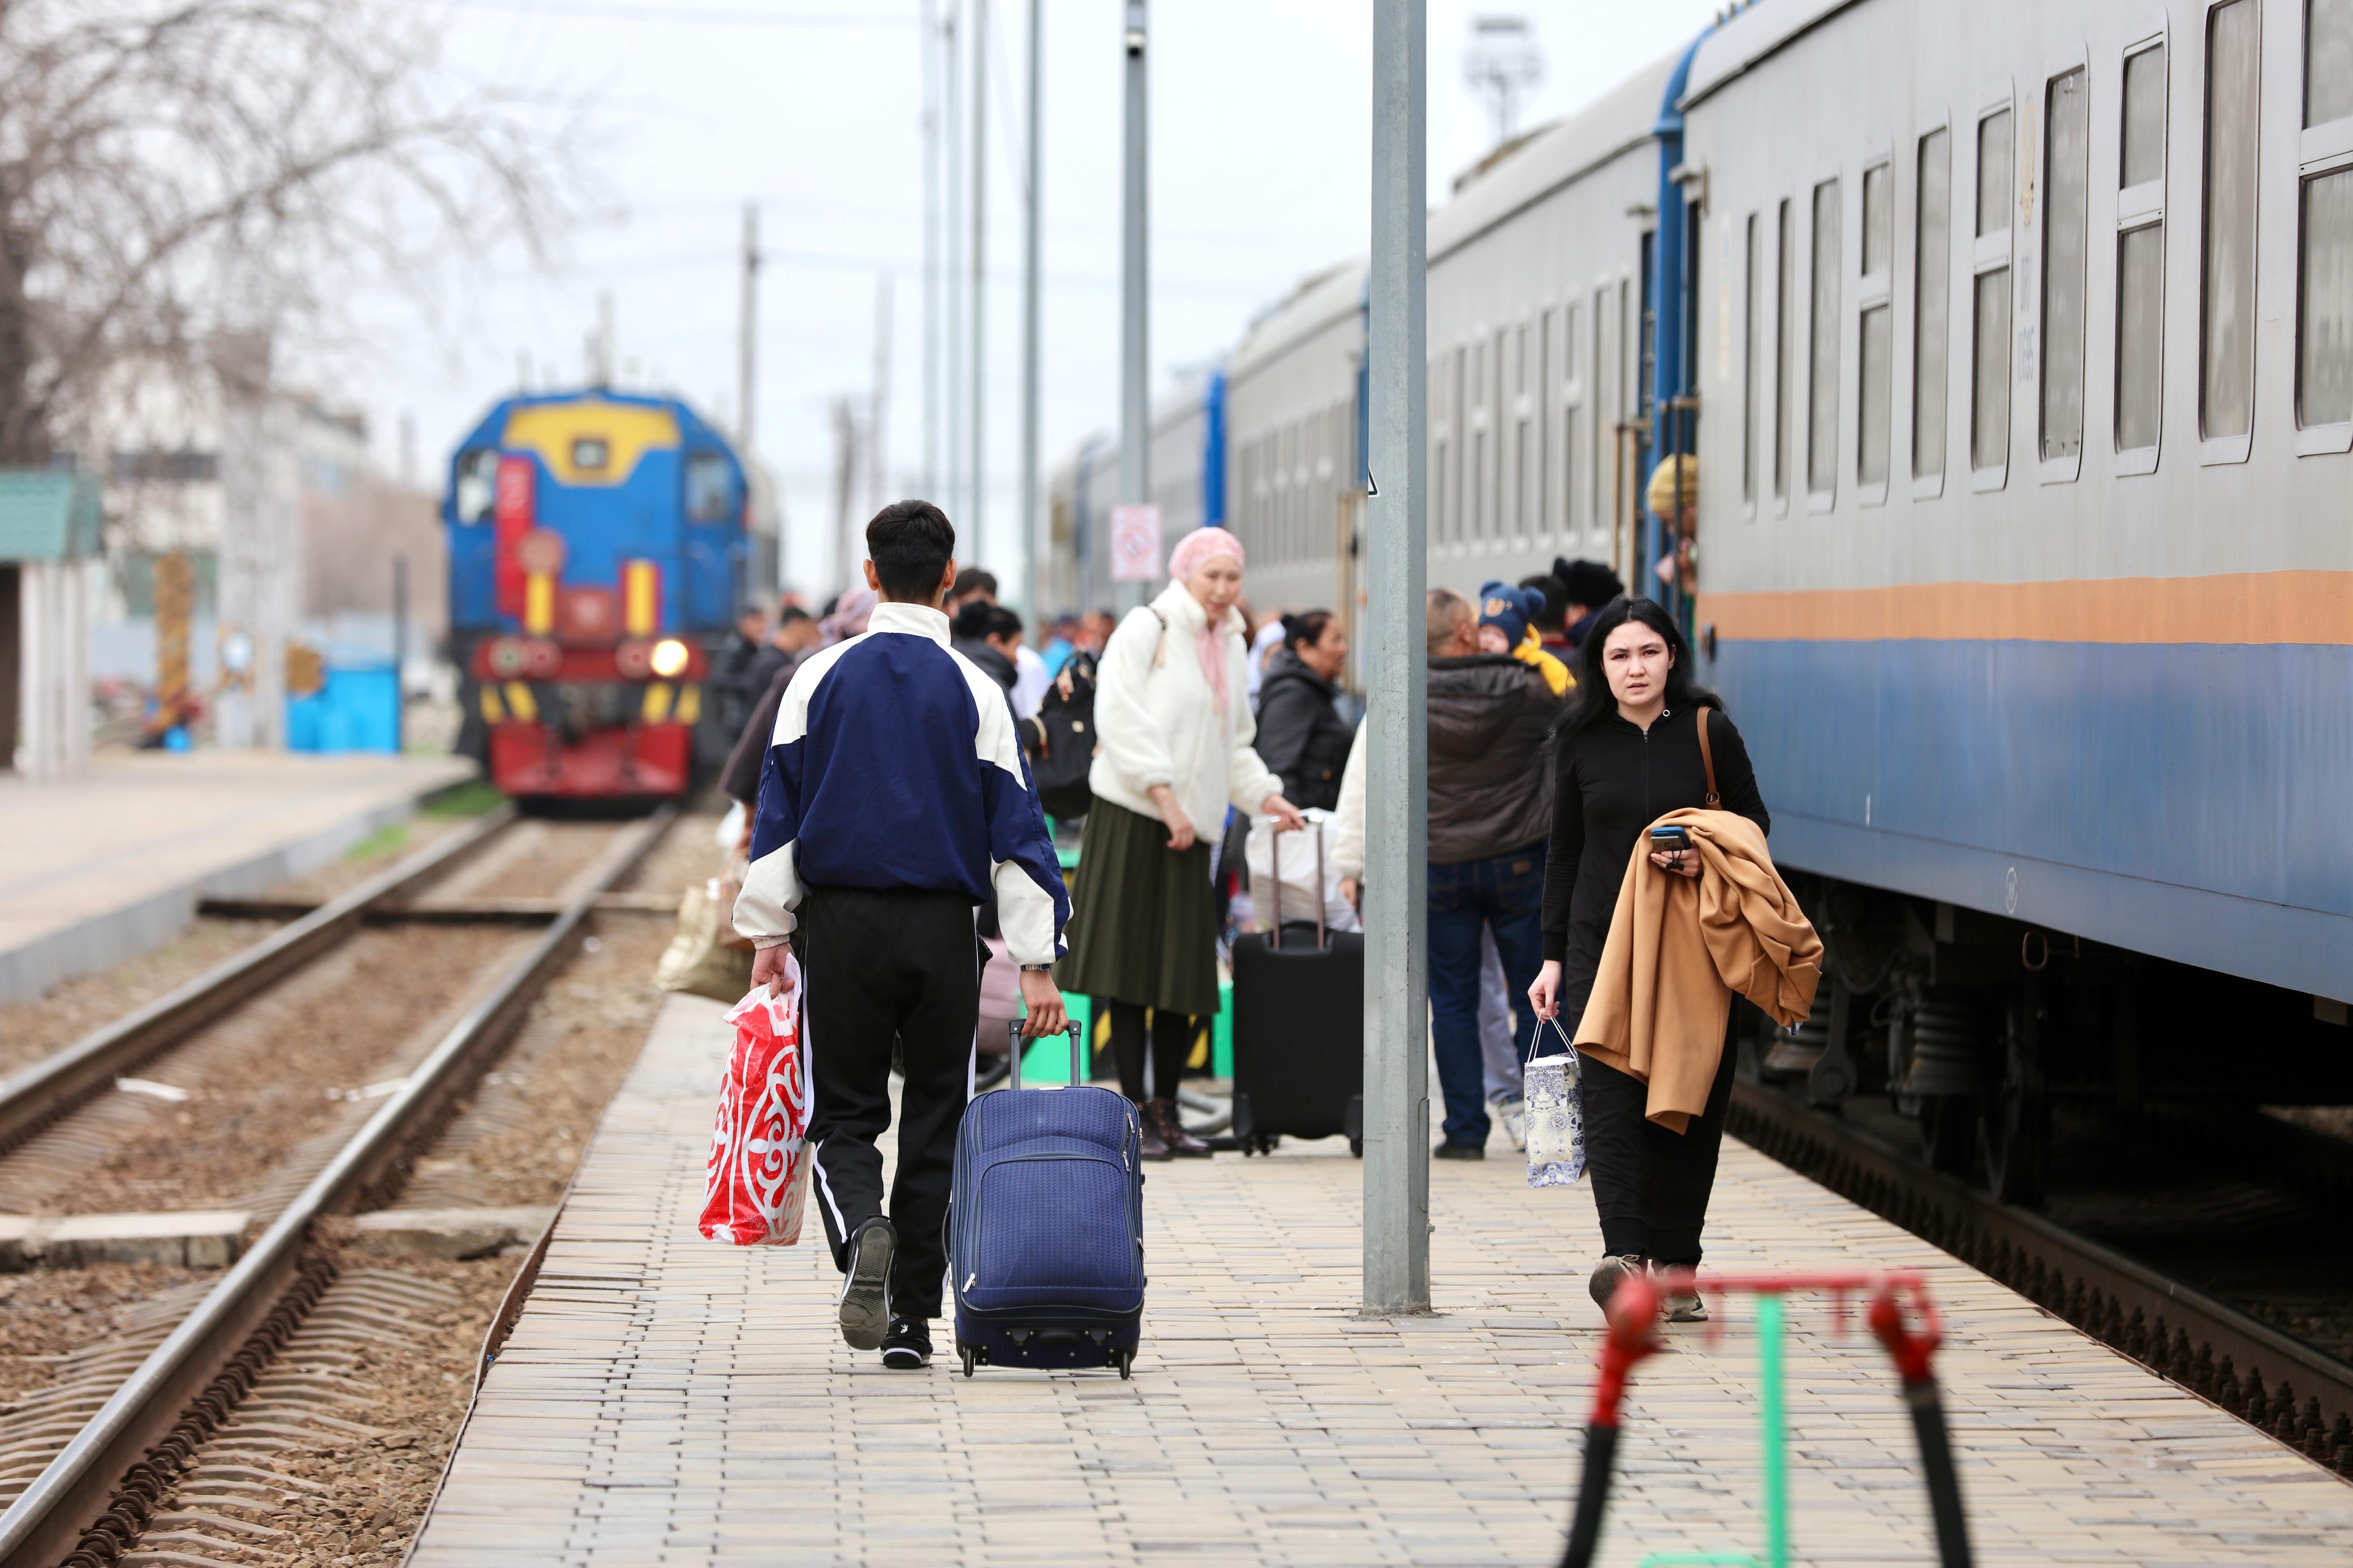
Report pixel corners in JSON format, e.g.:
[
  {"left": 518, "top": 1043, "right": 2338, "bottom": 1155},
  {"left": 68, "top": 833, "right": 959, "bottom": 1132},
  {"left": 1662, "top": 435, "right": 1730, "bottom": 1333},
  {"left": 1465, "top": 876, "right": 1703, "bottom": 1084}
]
[{"left": 0, "top": 809, "right": 675, "bottom": 1568}]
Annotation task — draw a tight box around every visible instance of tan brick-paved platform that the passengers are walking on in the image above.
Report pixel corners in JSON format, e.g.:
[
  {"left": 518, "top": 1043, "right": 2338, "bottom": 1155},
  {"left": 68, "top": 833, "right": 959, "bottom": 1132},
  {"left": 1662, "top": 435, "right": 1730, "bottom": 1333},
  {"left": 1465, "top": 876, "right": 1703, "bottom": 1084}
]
[{"left": 410, "top": 997, "right": 2353, "bottom": 1568}]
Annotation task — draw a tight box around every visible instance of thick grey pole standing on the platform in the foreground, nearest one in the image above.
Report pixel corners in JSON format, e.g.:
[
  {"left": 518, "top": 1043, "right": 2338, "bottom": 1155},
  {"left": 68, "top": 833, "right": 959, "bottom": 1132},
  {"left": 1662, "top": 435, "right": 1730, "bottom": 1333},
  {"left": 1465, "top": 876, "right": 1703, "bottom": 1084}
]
[{"left": 1365, "top": 0, "right": 1430, "bottom": 1314}]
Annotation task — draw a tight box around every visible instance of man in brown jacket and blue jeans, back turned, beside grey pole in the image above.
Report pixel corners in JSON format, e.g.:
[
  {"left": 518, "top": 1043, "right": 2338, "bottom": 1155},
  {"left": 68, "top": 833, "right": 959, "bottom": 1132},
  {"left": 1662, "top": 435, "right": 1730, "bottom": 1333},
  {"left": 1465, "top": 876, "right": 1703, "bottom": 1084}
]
[{"left": 1426, "top": 588, "right": 1560, "bottom": 1159}]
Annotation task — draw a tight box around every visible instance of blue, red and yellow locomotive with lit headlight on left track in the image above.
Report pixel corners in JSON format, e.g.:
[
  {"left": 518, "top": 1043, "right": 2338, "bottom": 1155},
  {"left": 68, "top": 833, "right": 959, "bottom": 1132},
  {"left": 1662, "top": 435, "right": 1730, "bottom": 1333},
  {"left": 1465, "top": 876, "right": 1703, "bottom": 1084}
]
[{"left": 442, "top": 388, "right": 774, "bottom": 797}]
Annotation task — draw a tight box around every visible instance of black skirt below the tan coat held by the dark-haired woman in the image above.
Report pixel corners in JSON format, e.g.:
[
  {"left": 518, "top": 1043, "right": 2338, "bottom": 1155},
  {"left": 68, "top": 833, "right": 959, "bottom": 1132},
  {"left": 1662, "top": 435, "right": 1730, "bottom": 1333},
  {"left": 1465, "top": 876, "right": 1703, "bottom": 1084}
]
[{"left": 1581, "top": 999, "right": 1741, "bottom": 1267}]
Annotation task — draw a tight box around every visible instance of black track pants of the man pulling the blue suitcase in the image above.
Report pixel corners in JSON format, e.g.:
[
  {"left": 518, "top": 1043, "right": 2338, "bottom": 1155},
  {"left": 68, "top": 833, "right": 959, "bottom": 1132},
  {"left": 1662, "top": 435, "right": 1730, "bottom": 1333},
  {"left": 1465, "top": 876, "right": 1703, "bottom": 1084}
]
[{"left": 800, "top": 886, "right": 986, "bottom": 1316}]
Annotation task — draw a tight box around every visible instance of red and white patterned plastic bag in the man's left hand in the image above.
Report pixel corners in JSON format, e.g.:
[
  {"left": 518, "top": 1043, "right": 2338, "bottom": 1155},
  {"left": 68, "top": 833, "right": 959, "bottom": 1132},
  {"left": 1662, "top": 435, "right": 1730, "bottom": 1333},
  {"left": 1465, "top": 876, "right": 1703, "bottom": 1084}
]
[{"left": 701, "top": 957, "right": 814, "bottom": 1246}]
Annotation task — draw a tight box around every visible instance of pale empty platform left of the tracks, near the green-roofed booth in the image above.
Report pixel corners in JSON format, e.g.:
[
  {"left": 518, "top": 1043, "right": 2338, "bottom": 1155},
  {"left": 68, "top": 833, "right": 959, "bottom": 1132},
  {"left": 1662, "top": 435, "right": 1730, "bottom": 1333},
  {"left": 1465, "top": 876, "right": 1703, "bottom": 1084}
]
[{"left": 0, "top": 750, "right": 473, "bottom": 1001}]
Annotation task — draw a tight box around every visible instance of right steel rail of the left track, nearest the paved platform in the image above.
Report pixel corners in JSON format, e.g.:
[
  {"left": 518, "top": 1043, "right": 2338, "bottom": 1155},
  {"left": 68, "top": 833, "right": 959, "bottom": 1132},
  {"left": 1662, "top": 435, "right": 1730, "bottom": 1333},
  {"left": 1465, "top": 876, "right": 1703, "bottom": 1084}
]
[{"left": 0, "top": 806, "right": 678, "bottom": 1568}]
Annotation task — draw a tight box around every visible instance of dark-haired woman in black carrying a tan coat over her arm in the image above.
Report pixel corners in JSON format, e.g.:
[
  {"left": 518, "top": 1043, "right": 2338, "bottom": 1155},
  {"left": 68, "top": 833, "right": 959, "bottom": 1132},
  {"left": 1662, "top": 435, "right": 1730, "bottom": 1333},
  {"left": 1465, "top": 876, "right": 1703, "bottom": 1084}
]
[{"left": 1527, "top": 597, "right": 1772, "bottom": 1321}]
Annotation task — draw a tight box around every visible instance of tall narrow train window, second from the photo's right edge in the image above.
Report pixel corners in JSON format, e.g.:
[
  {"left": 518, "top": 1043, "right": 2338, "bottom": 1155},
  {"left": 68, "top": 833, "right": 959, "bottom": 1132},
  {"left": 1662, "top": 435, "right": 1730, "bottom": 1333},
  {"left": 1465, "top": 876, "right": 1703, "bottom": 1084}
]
[{"left": 2197, "top": 0, "right": 2261, "bottom": 461}]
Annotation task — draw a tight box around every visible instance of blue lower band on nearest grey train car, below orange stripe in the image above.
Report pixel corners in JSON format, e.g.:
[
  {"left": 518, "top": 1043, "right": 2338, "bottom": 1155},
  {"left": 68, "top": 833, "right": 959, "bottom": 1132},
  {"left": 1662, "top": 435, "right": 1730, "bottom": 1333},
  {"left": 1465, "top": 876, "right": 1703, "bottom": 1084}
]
[{"left": 1708, "top": 640, "right": 2353, "bottom": 997}]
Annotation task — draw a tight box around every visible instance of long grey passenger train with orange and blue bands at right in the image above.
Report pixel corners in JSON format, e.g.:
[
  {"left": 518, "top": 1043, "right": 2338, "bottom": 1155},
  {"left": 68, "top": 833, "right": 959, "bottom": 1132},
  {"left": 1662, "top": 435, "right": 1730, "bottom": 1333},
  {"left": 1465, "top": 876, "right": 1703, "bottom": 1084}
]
[{"left": 1058, "top": 0, "right": 2353, "bottom": 1201}]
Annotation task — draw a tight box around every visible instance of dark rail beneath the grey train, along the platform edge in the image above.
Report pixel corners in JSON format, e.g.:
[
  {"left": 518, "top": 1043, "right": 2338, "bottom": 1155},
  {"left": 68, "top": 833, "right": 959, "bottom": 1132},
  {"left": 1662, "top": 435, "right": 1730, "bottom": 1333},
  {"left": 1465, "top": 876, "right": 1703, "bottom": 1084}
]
[{"left": 1727, "top": 1081, "right": 2353, "bottom": 1479}]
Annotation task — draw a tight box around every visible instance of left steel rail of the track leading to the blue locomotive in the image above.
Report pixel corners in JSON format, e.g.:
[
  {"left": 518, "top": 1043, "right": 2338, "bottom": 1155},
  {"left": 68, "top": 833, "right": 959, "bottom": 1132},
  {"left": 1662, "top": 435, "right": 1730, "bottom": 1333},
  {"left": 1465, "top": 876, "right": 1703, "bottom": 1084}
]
[{"left": 0, "top": 806, "right": 515, "bottom": 1154}]
